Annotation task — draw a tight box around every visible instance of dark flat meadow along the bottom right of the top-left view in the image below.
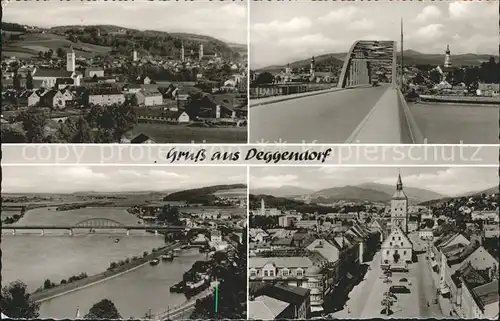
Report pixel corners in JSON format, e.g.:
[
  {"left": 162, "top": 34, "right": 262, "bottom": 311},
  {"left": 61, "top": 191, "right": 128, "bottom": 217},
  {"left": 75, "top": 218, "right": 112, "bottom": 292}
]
[{"left": 129, "top": 124, "right": 247, "bottom": 143}]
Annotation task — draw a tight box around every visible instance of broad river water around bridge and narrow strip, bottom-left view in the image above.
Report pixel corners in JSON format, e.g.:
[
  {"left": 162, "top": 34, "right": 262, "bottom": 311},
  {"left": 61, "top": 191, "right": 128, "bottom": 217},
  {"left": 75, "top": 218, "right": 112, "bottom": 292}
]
[{"left": 1, "top": 208, "right": 205, "bottom": 318}]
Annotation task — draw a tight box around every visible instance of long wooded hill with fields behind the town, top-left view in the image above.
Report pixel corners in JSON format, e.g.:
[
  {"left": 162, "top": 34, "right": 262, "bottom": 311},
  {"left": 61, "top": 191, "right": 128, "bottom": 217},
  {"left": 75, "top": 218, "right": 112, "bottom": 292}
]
[{"left": 2, "top": 24, "right": 241, "bottom": 59}]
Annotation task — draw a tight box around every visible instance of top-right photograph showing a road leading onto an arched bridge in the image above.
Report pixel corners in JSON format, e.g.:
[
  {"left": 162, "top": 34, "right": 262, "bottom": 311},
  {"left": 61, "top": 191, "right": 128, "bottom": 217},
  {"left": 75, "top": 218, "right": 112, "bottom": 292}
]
[{"left": 249, "top": 0, "right": 500, "bottom": 144}]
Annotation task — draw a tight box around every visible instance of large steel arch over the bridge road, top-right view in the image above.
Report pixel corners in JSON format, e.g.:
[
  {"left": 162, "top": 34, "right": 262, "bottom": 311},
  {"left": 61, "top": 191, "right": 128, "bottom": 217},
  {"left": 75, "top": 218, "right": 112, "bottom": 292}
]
[{"left": 337, "top": 40, "right": 396, "bottom": 88}]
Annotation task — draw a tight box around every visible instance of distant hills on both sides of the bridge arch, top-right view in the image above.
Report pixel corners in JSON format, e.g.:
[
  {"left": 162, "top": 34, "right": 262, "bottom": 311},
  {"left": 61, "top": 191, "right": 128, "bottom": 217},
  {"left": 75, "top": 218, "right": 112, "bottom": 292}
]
[{"left": 257, "top": 49, "right": 498, "bottom": 73}]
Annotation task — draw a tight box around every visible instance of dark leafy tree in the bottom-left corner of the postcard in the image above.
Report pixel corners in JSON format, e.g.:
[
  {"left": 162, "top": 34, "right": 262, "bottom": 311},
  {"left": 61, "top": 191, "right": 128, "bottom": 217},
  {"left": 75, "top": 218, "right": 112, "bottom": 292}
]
[{"left": 0, "top": 280, "right": 40, "bottom": 319}]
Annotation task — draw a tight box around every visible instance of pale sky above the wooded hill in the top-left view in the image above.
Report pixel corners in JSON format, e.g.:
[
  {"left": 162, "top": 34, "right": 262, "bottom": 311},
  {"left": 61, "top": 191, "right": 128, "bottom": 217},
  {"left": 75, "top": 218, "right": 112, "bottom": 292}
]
[{"left": 2, "top": 1, "right": 248, "bottom": 44}]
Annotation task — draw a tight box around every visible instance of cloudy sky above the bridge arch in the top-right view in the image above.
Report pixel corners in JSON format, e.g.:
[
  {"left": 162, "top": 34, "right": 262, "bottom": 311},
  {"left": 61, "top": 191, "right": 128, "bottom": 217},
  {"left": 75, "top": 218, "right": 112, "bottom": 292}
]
[{"left": 250, "top": 0, "right": 499, "bottom": 68}]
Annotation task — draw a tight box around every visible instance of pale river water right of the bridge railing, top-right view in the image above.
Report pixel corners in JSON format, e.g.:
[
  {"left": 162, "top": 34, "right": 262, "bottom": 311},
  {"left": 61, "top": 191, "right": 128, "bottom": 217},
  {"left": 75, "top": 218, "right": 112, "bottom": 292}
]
[{"left": 408, "top": 103, "right": 498, "bottom": 144}]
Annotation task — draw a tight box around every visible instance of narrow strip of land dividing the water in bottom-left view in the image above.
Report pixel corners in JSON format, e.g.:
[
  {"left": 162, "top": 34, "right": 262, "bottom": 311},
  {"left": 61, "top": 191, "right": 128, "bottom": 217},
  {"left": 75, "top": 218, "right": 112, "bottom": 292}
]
[{"left": 30, "top": 242, "right": 181, "bottom": 303}]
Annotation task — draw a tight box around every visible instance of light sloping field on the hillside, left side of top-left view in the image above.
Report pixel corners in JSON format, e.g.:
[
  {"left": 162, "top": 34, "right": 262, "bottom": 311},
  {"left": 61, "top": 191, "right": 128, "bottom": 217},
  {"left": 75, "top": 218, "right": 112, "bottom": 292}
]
[{"left": 2, "top": 33, "right": 111, "bottom": 57}]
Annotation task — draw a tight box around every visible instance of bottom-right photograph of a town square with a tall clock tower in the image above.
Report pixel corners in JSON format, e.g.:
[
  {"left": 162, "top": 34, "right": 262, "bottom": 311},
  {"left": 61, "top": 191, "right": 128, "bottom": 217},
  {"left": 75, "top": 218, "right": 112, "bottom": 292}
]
[{"left": 248, "top": 166, "right": 499, "bottom": 320}]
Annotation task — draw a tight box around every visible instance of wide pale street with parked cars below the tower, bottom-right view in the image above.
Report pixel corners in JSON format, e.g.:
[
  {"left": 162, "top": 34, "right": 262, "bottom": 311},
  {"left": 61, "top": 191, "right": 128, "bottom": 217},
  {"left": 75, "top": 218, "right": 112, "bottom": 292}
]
[{"left": 334, "top": 253, "right": 446, "bottom": 319}]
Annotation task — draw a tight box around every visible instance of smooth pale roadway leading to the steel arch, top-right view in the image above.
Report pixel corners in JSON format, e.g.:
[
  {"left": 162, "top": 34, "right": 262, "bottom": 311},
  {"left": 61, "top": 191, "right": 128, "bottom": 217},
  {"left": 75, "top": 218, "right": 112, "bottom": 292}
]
[{"left": 250, "top": 86, "right": 388, "bottom": 143}]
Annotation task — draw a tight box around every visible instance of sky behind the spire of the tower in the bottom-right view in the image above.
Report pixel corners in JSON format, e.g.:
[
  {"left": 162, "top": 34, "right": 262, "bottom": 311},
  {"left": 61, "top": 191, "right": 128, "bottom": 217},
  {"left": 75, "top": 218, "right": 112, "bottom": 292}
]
[{"left": 250, "top": 166, "right": 498, "bottom": 196}]
